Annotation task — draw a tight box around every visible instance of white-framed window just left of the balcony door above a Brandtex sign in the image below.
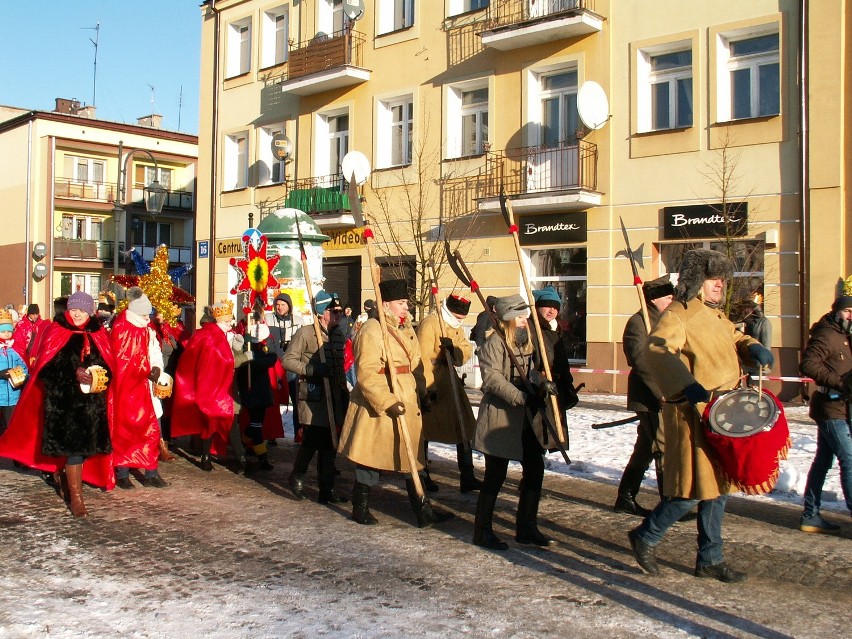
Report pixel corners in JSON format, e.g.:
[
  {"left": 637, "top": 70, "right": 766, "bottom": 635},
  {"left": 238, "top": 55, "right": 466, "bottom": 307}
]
[{"left": 447, "top": 81, "right": 488, "bottom": 158}]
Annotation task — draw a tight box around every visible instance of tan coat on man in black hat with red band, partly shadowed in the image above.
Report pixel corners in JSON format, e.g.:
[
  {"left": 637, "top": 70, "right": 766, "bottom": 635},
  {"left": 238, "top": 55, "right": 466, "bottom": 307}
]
[{"left": 417, "top": 311, "right": 476, "bottom": 444}]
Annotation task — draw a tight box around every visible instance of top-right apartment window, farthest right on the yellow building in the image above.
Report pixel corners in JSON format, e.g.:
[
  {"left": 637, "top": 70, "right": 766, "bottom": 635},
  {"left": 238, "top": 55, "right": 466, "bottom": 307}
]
[{"left": 717, "top": 25, "right": 781, "bottom": 121}]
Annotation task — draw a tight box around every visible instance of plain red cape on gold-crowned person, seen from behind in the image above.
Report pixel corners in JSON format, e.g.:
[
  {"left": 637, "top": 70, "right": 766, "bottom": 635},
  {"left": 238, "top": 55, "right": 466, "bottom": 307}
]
[{"left": 172, "top": 322, "right": 234, "bottom": 454}]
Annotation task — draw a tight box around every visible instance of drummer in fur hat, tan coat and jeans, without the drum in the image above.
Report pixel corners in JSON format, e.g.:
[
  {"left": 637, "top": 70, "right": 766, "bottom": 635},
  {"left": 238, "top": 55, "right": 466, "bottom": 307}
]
[{"left": 629, "top": 249, "right": 774, "bottom": 583}]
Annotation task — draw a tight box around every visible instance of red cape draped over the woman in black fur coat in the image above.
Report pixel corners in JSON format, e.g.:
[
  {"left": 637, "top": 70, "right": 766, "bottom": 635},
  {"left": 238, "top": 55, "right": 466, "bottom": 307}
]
[{"left": 0, "top": 323, "right": 115, "bottom": 490}]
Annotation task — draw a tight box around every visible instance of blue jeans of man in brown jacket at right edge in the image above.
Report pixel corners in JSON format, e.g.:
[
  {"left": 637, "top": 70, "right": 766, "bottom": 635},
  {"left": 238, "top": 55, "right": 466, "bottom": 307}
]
[{"left": 802, "top": 419, "right": 852, "bottom": 517}]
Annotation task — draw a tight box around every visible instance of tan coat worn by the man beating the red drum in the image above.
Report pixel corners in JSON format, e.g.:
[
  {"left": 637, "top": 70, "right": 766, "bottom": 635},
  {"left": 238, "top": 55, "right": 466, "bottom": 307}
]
[{"left": 645, "top": 299, "right": 758, "bottom": 499}]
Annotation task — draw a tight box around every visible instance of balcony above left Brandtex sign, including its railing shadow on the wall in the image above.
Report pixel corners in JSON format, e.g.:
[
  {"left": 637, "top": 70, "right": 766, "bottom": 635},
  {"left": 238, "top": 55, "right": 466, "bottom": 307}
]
[{"left": 442, "top": 140, "right": 601, "bottom": 213}]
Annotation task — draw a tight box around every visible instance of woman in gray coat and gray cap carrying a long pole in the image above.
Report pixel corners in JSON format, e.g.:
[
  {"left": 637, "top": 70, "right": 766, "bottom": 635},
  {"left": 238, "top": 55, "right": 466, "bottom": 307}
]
[{"left": 473, "top": 295, "right": 555, "bottom": 550}]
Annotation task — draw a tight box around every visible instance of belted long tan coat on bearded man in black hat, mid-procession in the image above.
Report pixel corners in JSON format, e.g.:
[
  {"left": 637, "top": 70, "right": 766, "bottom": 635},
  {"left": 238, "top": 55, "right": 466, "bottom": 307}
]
[{"left": 338, "top": 313, "right": 425, "bottom": 473}]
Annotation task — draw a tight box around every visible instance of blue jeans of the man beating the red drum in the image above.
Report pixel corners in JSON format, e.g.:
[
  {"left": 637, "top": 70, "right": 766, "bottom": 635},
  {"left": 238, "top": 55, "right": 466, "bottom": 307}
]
[{"left": 636, "top": 495, "right": 728, "bottom": 567}]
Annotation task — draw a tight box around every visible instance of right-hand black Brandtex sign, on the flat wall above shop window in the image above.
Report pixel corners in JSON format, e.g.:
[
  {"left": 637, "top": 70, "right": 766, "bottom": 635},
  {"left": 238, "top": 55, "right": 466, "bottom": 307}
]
[{"left": 663, "top": 202, "right": 748, "bottom": 240}]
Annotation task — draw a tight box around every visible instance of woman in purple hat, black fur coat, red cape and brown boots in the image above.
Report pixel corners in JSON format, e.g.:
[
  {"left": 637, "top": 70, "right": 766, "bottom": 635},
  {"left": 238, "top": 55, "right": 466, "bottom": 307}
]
[{"left": 0, "top": 291, "right": 115, "bottom": 517}]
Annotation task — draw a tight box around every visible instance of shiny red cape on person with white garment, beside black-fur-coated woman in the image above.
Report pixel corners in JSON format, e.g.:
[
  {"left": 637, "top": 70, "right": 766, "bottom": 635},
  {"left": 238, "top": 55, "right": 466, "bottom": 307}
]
[{"left": 110, "top": 311, "right": 160, "bottom": 470}]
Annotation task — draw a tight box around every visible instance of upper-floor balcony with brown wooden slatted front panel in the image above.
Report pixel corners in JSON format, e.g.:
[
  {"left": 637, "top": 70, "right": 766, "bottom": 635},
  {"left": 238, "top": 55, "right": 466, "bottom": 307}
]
[{"left": 280, "top": 29, "right": 370, "bottom": 95}]
